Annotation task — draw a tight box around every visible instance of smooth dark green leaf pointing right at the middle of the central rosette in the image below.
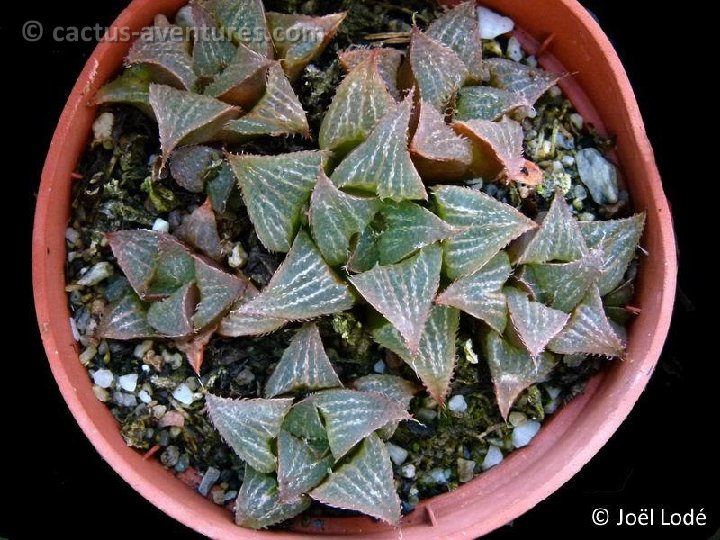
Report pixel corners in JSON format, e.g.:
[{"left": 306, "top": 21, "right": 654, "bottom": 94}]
[{"left": 377, "top": 201, "right": 458, "bottom": 264}]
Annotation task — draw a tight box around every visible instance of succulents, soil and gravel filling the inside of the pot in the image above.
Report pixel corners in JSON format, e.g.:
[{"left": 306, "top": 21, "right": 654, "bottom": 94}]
[{"left": 66, "top": 0, "right": 652, "bottom": 529}]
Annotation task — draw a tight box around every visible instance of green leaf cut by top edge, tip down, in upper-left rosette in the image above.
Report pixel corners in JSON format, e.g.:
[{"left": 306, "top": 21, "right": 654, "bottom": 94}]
[{"left": 204, "top": 0, "right": 274, "bottom": 58}]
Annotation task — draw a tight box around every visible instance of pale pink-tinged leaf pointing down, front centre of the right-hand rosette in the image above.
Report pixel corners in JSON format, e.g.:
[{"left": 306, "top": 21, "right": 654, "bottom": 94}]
[{"left": 505, "top": 287, "right": 570, "bottom": 357}]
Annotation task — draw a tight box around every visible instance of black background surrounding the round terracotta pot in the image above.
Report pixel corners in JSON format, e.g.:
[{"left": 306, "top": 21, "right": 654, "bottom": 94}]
[{"left": 0, "top": 0, "right": 720, "bottom": 540}]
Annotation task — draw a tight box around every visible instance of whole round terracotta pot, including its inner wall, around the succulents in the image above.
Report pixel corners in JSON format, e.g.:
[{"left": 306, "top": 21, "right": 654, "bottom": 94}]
[{"left": 33, "top": 0, "right": 677, "bottom": 540}]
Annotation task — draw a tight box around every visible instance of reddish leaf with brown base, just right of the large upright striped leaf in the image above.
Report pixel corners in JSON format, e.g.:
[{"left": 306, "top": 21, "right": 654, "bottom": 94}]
[{"left": 410, "top": 100, "right": 473, "bottom": 181}]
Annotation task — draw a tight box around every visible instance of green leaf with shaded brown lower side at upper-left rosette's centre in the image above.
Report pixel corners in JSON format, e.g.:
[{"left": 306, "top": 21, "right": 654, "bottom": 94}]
[{"left": 205, "top": 45, "right": 273, "bottom": 106}]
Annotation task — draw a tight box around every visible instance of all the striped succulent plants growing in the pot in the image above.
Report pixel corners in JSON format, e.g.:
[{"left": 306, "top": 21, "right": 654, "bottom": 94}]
[{"left": 95, "top": 0, "right": 644, "bottom": 528}]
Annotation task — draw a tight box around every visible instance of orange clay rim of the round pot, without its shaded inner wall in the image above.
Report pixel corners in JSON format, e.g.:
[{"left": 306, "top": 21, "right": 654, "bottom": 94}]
[{"left": 33, "top": 0, "right": 677, "bottom": 538}]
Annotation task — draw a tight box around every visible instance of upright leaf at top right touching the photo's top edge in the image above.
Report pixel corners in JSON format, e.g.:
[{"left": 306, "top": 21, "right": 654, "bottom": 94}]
[{"left": 427, "top": 0, "right": 483, "bottom": 83}]
